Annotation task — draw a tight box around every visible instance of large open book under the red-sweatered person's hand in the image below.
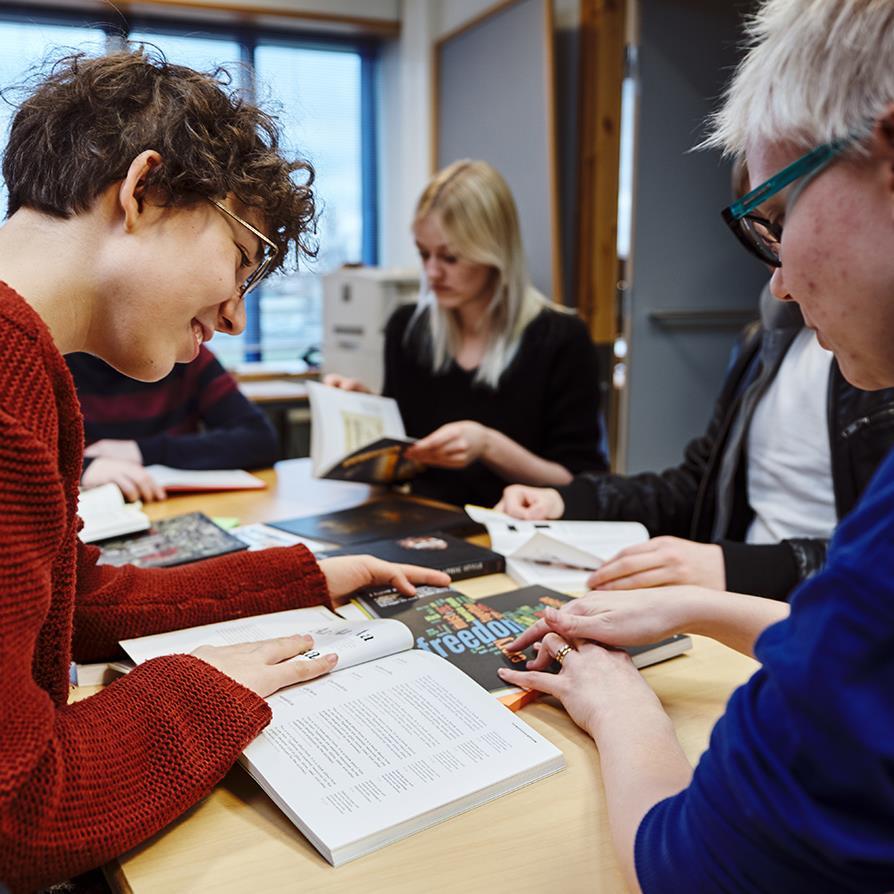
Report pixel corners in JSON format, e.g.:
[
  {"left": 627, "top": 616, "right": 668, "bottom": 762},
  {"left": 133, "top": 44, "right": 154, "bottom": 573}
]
[{"left": 121, "top": 607, "right": 565, "bottom": 866}]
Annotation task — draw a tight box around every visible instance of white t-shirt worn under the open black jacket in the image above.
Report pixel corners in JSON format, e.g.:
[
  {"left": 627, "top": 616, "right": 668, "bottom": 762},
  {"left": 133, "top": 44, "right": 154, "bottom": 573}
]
[{"left": 745, "top": 329, "right": 838, "bottom": 543}]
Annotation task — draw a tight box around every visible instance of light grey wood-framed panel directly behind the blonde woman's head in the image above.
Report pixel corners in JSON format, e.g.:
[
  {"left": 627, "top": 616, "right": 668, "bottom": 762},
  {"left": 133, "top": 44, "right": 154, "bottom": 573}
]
[{"left": 437, "top": 0, "right": 554, "bottom": 295}]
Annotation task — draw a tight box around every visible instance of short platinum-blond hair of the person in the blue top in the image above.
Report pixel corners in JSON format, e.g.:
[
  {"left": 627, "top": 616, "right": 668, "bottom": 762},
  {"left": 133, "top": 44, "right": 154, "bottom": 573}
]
[{"left": 701, "top": 0, "right": 894, "bottom": 156}]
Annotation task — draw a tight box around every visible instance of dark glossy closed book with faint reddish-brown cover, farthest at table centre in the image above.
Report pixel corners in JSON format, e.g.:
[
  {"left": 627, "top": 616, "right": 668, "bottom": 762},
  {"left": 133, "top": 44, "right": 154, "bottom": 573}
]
[{"left": 269, "top": 497, "right": 484, "bottom": 546}]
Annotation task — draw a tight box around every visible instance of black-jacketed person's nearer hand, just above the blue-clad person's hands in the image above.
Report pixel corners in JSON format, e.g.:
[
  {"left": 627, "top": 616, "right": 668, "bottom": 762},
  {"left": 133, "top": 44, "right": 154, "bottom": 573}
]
[{"left": 587, "top": 537, "right": 726, "bottom": 590}]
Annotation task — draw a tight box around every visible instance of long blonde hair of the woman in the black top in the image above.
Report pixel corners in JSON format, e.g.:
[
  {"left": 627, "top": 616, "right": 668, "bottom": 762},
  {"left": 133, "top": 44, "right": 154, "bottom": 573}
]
[{"left": 407, "top": 159, "right": 551, "bottom": 388}]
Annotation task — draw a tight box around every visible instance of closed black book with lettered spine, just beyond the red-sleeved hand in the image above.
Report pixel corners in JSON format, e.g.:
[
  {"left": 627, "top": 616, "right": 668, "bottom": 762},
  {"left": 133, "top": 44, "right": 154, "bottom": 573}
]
[{"left": 320, "top": 531, "right": 506, "bottom": 593}]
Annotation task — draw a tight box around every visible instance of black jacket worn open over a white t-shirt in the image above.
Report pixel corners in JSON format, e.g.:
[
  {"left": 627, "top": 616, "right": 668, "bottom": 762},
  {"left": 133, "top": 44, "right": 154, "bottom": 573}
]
[{"left": 558, "top": 302, "right": 894, "bottom": 599}]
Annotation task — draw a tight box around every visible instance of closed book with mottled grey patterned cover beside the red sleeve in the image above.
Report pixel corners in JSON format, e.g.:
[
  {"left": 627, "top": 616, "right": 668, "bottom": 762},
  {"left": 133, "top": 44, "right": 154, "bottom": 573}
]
[{"left": 98, "top": 512, "right": 248, "bottom": 568}]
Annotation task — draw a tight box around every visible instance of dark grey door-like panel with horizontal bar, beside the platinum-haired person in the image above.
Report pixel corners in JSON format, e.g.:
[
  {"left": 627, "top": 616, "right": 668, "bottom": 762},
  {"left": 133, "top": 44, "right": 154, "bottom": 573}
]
[{"left": 624, "top": 0, "right": 767, "bottom": 472}]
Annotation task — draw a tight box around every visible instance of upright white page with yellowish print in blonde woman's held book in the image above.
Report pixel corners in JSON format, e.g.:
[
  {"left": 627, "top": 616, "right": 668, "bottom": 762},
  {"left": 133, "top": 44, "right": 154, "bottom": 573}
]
[{"left": 307, "top": 382, "right": 410, "bottom": 478}]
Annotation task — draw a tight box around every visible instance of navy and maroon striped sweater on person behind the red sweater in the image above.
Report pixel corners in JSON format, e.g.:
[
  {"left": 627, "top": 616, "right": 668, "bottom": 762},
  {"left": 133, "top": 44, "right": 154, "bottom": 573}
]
[{"left": 66, "top": 346, "right": 278, "bottom": 469}]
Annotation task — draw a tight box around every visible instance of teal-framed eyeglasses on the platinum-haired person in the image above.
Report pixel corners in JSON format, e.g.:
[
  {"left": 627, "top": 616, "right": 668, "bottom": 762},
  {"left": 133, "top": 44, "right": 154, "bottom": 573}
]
[{"left": 721, "top": 137, "right": 855, "bottom": 267}]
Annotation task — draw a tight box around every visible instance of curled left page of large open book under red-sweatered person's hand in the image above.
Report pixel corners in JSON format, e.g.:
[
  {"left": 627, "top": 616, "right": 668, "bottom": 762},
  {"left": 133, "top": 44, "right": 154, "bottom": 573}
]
[{"left": 121, "top": 606, "right": 413, "bottom": 670}]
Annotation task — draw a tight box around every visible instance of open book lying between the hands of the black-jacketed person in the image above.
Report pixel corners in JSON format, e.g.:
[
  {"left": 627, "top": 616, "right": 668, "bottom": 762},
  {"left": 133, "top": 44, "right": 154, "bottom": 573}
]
[{"left": 466, "top": 506, "right": 649, "bottom": 593}]
